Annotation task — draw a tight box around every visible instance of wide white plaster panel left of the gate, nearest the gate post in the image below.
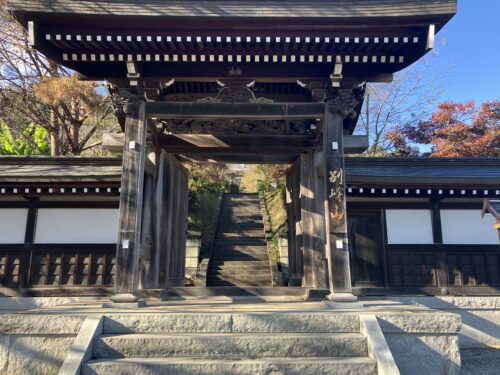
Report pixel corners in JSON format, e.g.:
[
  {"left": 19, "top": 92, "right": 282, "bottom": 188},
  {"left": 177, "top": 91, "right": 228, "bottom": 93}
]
[{"left": 35, "top": 208, "right": 119, "bottom": 243}]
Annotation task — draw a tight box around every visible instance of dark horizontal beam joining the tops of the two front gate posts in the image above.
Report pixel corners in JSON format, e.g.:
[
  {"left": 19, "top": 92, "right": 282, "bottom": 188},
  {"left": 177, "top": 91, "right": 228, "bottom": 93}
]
[{"left": 146, "top": 102, "right": 324, "bottom": 120}]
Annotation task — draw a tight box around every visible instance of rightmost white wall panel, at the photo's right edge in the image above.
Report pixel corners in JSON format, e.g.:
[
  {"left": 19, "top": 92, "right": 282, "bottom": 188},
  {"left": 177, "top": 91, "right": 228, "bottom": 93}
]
[{"left": 441, "top": 210, "right": 499, "bottom": 245}]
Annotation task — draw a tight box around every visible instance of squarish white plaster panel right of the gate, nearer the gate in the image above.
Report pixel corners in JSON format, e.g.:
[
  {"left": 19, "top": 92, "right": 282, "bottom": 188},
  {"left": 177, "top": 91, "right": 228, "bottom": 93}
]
[{"left": 385, "top": 210, "right": 434, "bottom": 245}]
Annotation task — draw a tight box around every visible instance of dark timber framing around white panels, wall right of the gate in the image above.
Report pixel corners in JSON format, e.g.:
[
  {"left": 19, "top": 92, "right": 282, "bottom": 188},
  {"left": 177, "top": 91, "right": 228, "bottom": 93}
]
[{"left": 347, "top": 194, "right": 500, "bottom": 295}]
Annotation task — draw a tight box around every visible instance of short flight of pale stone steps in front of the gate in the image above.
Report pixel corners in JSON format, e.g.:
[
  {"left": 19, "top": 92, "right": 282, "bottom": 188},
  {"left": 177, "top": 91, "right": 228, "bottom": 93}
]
[{"left": 81, "top": 312, "right": 377, "bottom": 375}]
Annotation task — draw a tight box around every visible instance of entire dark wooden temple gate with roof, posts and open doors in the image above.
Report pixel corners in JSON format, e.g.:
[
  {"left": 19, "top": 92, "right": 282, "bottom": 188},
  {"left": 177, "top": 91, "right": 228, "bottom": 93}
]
[{"left": 9, "top": 0, "right": 456, "bottom": 302}]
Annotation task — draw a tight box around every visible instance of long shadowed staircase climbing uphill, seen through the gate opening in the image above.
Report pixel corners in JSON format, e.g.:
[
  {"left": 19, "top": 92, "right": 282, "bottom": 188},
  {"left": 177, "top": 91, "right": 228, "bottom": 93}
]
[{"left": 207, "top": 194, "right": 272, "bottom": 287}]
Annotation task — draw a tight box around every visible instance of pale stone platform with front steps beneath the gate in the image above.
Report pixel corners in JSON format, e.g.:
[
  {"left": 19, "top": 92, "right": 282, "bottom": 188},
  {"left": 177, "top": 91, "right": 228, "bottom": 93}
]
[{"left": 0, "top": 296, "right": 468, "bottom": 374}]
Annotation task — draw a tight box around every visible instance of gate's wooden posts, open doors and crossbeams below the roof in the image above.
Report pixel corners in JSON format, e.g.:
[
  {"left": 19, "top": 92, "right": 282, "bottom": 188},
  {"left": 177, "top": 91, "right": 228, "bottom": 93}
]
[{"left": 111, "top": 92, "right": 363, "bottom": 301}]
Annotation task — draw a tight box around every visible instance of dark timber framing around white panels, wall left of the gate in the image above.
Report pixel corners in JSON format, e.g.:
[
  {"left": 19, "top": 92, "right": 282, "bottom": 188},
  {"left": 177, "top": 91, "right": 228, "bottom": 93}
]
[{"left": 0, "top": 194, "right": 119, "bottom": 296}]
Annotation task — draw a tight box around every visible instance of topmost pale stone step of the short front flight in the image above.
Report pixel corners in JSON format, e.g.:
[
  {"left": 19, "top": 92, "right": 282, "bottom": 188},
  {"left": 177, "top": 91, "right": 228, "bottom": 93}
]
[{"left": 104, "top": 314, "right": 360, "bottom": 334}]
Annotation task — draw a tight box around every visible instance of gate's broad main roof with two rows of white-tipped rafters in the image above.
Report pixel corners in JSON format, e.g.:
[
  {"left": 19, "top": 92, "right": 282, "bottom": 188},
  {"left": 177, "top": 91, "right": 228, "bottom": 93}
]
[{"left": 9, "top": 0, "right": 456, "bottom": 83}]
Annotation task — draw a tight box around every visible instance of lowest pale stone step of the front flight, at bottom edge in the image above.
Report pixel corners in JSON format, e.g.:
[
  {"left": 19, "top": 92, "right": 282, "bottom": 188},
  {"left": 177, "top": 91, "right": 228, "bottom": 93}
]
[{"left": 82, "top": 357, "right": 377, "bottom": 375}]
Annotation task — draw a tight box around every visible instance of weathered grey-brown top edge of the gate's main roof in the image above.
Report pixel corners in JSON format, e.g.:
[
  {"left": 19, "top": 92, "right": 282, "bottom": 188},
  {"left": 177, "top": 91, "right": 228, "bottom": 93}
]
[{"left": 9, "top": 0, "right": 456, "bottom": 23}]
